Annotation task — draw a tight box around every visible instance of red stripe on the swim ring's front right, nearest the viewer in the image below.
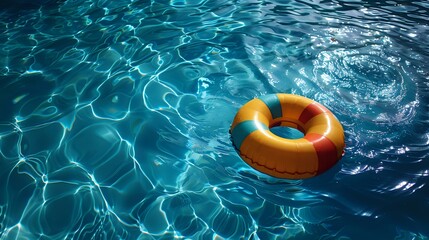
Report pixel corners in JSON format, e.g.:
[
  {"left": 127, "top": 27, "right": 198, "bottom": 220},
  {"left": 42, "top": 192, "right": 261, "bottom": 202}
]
[{"left": 304, "top": 133, "right": 338, "bottom": 174}]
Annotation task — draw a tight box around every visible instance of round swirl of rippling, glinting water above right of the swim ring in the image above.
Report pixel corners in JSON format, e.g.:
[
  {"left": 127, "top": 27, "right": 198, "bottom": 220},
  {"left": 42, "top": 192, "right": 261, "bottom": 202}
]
[{"left": 314, "top": 49, "right": 416, "bottom": 124}]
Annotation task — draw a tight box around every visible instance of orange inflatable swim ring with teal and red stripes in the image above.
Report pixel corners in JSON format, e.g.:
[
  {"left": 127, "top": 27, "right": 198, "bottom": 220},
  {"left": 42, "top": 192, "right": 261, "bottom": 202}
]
[{"left": 230, "top": 94, "right": 345, "bottom": 179}]
